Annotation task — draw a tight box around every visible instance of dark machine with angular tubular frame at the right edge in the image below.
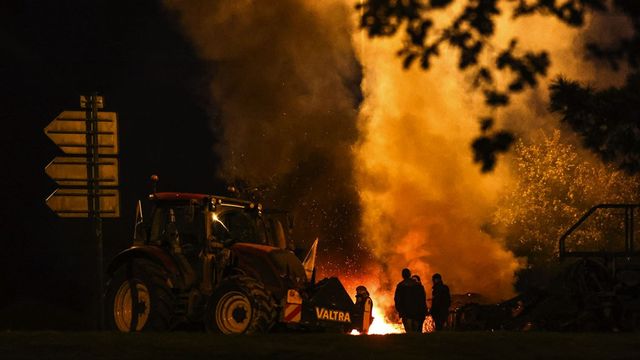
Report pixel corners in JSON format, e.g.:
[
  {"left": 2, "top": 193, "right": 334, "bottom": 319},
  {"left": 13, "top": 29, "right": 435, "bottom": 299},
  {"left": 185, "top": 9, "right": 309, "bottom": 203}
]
[{"left": 559, "top": 204, "right": 640, "bottom": 331}]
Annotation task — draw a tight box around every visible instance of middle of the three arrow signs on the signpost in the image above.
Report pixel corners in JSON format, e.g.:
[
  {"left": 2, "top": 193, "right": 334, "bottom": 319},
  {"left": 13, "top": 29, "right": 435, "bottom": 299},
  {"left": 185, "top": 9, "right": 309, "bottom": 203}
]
[{"left": 44, "top": 156, "right": 118, "bottom": 187}]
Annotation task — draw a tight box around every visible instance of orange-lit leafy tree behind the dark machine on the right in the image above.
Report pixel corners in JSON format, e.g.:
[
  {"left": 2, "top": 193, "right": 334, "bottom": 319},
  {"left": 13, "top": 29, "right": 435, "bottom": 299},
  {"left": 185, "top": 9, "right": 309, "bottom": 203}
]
[{"left": 493, "top": 130, "right": 640, "bottom": 267}]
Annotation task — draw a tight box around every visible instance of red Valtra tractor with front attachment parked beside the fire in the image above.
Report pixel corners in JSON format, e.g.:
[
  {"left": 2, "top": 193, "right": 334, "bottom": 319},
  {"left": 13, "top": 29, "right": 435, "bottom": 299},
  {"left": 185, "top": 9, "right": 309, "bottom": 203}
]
[{"left": 105, "top": 183, "right": 372, "bottom": 334}]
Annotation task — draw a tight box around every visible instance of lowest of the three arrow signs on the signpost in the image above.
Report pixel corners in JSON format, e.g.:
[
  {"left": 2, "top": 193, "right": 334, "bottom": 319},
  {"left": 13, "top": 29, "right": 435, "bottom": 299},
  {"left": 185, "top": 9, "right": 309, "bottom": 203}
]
[{"left": 47, "top": 189, "right": 120, "bottom": 218}]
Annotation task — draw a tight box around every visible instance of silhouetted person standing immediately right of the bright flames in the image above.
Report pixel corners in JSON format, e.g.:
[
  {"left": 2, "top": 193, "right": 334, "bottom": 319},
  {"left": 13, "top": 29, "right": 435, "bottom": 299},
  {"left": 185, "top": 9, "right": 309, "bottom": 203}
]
[{"left": 393, "top": 269, "right": 426, "bottom": 333}]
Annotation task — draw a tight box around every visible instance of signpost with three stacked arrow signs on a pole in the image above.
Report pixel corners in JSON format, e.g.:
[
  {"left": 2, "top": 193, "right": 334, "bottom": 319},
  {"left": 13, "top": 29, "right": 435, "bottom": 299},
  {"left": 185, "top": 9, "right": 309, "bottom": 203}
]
[{"left": 44, "top": 94, "right": 120, "bottom": 329}]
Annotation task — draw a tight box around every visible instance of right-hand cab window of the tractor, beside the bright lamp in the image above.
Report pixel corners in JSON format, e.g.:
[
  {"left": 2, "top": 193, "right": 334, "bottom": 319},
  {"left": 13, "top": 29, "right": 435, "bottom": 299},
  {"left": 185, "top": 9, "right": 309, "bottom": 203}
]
[{"left": 212, "top": 210, "right": 264, "bottom": 244}]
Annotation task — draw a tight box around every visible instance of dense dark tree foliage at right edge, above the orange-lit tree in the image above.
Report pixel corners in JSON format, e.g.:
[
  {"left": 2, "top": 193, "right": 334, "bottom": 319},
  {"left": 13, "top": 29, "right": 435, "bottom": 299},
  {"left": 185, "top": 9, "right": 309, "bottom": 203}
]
[{"left": 550, "top": 0, "right": 640, "bottom": 174}]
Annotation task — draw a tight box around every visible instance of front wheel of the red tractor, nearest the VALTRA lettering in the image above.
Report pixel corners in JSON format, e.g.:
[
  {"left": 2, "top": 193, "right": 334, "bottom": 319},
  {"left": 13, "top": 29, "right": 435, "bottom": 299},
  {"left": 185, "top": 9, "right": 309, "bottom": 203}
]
[{"left": 205, "top": 275, "right": 276, "bottom": 335}]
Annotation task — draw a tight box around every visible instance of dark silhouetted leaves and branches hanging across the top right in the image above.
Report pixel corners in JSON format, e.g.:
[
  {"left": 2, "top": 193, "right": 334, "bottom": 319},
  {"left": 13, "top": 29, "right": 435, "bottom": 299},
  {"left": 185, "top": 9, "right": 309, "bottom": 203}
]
[{"left": 357, "top": 0, "right": 640, "bottom": 172}]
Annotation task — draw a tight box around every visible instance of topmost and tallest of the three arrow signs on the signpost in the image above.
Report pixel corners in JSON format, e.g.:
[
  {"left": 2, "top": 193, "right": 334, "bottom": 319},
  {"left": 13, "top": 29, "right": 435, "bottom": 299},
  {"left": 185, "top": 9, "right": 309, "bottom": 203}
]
[{"left": 44, "top": 111, "right": 118, "bottom": 155}]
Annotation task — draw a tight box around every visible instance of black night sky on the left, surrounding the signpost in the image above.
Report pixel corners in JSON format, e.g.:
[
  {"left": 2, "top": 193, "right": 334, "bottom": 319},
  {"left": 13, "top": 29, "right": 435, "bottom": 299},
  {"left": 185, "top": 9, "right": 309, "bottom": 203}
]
[{"left": 0, "top": 0, "right": 224, "bottom": 329}]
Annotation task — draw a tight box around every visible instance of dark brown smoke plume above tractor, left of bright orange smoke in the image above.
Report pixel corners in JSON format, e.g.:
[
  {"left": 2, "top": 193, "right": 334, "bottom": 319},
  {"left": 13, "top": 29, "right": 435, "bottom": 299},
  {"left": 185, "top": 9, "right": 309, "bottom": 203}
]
[{"left": 166, "top": 0, "right": 361, "bottom": 261}]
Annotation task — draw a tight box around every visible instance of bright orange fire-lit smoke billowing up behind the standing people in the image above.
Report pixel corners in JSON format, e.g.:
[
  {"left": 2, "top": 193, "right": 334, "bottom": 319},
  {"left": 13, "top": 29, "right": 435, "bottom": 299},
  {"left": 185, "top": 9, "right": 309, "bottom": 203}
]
[{"left": 354, "top": 7, "right": 623, "bottom": 301}]
